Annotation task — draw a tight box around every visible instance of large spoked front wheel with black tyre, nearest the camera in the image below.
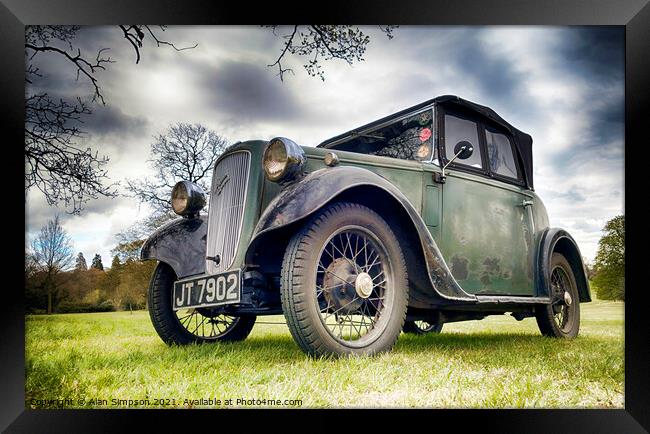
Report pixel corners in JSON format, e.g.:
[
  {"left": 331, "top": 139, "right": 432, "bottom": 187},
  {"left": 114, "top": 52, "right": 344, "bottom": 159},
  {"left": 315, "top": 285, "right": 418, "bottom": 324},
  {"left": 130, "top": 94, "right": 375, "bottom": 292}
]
[{"left": 281, "top": 202, "right": 408, "bottom": 357}]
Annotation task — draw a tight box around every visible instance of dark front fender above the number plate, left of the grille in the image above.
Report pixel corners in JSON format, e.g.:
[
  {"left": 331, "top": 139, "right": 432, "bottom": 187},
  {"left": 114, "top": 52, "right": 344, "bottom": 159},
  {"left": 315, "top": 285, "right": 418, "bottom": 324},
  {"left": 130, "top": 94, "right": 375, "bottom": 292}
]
[{"left": 140, "top": 216, "right": 208, "bottom": 279}]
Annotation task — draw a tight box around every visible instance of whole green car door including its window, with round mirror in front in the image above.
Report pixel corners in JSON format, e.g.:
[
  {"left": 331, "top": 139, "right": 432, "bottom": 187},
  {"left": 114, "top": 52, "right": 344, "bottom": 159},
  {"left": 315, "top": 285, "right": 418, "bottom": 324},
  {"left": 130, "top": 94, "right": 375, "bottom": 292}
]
[{"left": 432, "top": 110, "right": 534, "bottom": 295}]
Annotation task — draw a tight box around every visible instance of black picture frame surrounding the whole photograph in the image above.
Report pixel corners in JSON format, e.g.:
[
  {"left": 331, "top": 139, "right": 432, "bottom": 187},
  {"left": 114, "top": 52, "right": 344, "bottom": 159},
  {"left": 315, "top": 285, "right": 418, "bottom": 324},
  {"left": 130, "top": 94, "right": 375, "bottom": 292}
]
[{"left": 0, "top": 0, "right": 650, "bottom": 433}]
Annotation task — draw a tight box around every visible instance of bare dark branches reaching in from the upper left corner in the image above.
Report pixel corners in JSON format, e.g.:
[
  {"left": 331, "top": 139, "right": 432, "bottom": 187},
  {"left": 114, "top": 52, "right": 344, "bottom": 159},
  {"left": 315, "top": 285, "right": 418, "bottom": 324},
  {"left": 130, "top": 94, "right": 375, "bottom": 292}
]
[{"left": 25, "top": 25, "right": 196, "bottom": 214}]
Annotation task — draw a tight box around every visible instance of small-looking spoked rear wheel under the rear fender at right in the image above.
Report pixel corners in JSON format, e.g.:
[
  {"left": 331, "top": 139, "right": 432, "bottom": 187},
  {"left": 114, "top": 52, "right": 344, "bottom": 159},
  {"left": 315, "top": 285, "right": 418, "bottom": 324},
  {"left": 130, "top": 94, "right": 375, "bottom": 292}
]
[{"left": 535, "top": 253, "right": 580, "bottom": 339}]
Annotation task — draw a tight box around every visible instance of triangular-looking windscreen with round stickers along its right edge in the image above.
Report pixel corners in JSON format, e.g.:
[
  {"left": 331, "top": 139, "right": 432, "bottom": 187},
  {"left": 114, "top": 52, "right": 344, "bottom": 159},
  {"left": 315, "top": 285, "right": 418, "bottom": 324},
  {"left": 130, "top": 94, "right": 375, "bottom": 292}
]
[{"left": 332, "top": 109, "right": 436, "bottom": 161}]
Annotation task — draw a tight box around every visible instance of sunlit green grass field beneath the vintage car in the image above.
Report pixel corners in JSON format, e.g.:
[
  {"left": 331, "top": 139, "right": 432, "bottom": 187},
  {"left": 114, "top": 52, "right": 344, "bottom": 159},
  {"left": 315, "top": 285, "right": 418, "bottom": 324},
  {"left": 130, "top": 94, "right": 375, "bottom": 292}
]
[{"left": 26, "top": 301, "right": 624, "bottom": 408}]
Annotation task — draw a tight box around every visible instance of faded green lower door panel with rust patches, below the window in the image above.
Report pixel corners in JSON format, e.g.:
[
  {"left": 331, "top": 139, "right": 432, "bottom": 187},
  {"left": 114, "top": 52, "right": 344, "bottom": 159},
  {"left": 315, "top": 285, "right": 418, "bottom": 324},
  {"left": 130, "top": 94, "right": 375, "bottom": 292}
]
[{"left": 440, "top": 170, "right": 542, "bottom": 296}]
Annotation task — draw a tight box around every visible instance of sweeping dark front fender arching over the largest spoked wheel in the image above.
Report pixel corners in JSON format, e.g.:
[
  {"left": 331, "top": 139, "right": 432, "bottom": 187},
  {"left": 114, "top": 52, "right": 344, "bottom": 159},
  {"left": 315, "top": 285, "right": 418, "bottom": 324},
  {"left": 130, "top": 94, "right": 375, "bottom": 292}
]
[{"left": 246, "top": 166, "right": 477, "bottom": 303}]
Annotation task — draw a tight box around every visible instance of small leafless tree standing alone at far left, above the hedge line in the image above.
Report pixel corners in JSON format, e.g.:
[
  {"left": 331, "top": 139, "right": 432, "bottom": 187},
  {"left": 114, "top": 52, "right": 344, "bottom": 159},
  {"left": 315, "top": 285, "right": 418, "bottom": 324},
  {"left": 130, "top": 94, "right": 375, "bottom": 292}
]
[{"left": 31, "top": 215, "right": 74, "bottom": 314}]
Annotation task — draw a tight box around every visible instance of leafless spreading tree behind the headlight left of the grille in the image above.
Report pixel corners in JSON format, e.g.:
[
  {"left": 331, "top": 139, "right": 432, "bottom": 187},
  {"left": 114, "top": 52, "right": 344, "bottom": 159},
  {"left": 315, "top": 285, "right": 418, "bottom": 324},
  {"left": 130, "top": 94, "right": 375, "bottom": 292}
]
[{"left": 127, "top": 123, "right": 228, "bottom": 215}]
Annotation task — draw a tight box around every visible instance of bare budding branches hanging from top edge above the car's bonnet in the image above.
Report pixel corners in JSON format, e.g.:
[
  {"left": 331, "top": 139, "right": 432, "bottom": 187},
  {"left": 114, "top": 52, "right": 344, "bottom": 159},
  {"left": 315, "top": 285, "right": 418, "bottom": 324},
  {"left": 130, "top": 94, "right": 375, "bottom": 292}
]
[{"left": 263, "top": 25, "right": 397, "bottom": 80}]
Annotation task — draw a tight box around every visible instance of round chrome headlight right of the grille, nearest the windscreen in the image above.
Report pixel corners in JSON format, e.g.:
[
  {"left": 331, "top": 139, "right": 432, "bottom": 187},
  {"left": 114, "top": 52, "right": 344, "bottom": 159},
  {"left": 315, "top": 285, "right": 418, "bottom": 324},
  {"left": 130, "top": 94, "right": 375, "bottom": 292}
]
[{"left": 262, "top": 137, "right": 305, "bottom": 182}]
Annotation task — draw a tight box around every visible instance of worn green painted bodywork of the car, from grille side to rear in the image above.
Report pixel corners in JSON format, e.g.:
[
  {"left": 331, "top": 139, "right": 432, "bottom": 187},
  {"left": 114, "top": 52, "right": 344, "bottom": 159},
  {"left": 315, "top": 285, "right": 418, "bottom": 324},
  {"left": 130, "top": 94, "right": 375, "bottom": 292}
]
[{"left": 223, "top": 133, "right": 548, "bottom": 295}]
